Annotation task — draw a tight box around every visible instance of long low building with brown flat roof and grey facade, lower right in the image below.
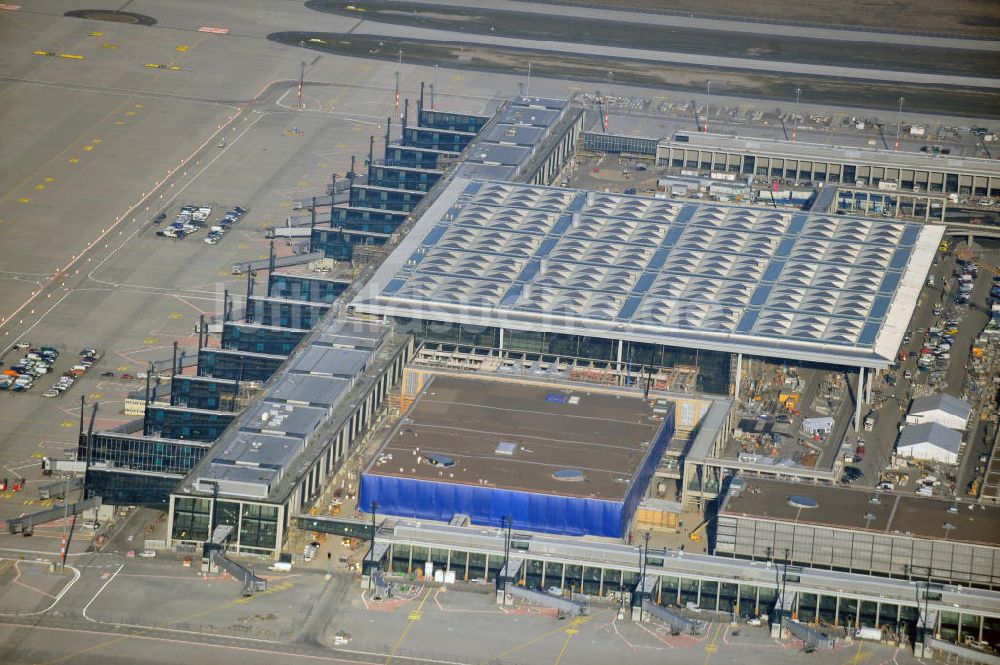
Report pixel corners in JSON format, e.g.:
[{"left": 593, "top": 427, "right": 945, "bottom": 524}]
[{"left": 714, "top": 478, "right": 1000, "bottom": 591}]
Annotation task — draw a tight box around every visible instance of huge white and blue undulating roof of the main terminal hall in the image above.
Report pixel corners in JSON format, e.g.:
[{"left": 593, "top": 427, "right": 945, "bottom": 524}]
[{"left": 354, "top": 178, "right": 943, "bottom": 367}]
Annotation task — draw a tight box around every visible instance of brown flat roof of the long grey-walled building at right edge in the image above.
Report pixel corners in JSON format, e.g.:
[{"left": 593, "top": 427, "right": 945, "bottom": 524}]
[{"left": 722, "top": 478, "right": 1000, "bottom": 547}]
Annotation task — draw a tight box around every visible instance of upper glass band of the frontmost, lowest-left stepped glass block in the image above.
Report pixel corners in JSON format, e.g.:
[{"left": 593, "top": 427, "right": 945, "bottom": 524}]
[{"left": 84, "top": 432, "right": 209, "bottom": 474}]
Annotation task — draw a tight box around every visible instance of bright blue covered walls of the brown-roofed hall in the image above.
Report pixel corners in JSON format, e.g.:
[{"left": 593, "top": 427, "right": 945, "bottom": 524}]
[{"left": 358, "top": 409, "right": 674, "bottom": 538}]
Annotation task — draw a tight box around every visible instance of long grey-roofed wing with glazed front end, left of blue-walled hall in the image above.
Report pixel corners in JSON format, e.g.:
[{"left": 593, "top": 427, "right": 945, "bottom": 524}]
[{"left": 168, "top": 319, "right": 413, "bottom": 558}]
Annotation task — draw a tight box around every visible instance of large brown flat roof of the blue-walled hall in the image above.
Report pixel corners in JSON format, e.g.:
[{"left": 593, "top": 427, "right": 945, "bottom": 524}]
[{"left": 368, "top": 375, "right": 663, "bottom": 501}]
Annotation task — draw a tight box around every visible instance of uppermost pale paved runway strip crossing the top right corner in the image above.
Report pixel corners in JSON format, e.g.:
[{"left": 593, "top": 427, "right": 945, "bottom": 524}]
[{"left": 388, "top": 0, "right": 1000, "bottom": 51}]
